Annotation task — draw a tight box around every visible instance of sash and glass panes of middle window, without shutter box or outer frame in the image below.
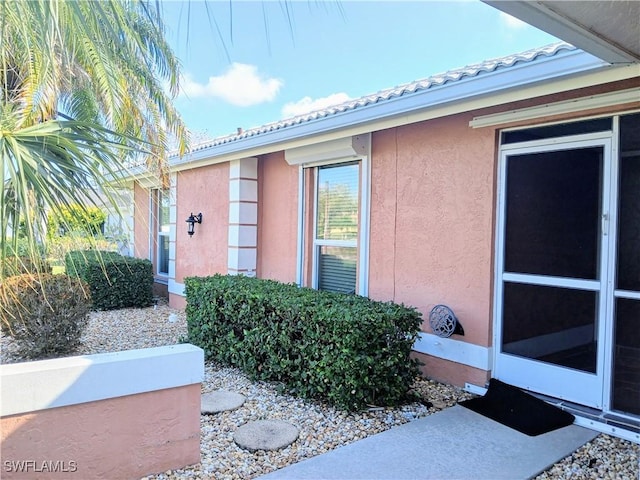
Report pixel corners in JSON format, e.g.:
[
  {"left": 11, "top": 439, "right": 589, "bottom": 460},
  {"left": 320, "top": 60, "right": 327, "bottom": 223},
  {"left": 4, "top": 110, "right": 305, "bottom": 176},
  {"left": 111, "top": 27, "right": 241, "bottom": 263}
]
[{"left": 313, "top": 163, "right": 360, "bottom": 293}]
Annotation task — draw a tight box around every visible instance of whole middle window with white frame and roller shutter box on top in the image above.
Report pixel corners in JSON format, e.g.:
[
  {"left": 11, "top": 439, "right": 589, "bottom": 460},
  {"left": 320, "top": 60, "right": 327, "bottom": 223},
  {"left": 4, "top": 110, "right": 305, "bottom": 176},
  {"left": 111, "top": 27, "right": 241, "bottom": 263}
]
[{"left": 292, "top": 134, "right": 371, "bottom": 296}]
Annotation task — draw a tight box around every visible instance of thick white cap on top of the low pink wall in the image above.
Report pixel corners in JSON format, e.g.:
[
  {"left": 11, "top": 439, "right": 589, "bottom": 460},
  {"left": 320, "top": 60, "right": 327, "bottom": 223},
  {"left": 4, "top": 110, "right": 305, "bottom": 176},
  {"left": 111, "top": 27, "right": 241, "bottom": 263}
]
[{"left": 0, "top": 344, "right": 204, "bottom": 417}]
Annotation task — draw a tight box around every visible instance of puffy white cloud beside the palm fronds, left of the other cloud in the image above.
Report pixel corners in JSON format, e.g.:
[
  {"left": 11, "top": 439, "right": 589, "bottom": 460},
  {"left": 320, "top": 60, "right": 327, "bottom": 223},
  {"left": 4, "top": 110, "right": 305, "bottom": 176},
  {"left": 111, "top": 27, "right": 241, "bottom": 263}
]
[{"left": 181, "top": 63, "right": 283, "bottom": 107}]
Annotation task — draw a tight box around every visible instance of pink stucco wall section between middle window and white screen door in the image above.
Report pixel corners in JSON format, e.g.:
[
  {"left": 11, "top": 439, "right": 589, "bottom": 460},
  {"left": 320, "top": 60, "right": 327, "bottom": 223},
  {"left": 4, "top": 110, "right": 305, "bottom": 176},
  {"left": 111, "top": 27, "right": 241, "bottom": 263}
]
[{"left": 369, "top": 115, "right": 496, "bottom": 346}]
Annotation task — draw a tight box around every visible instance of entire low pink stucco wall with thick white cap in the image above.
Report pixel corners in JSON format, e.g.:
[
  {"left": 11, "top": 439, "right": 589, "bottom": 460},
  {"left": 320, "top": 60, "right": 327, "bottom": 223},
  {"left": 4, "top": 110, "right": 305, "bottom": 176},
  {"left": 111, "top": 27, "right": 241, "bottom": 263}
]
[{"left": 0, "top": 344, "right": 204, "bottom": 480}]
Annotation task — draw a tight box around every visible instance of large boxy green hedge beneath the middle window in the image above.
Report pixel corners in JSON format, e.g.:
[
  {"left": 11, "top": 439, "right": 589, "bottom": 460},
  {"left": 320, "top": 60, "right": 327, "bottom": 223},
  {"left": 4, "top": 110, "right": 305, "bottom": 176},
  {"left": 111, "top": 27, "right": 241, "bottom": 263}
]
[{"left": 185, "top": 275, "right": 422, "bottom": 410}]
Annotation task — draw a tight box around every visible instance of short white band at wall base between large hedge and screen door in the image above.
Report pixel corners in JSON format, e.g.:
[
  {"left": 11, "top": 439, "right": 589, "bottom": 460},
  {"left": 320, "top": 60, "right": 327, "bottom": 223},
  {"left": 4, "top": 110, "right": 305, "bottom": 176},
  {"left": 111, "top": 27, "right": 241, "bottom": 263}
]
[{"left": 413, "top": 332, "right": 493, "bottom": 371}]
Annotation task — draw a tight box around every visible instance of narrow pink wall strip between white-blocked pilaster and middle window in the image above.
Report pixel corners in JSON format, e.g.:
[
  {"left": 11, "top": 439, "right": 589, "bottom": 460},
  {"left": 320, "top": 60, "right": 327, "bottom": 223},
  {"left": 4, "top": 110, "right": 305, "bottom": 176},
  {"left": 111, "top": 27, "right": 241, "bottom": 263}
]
[{"left": 257, "top": 152, "right": 298, "bottom": 282}]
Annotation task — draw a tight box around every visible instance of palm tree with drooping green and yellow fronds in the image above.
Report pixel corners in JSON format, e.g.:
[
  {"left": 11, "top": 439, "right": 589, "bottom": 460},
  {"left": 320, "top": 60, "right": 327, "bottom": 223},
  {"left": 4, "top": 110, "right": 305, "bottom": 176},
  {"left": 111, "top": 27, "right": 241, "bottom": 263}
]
[{"left": 0, "top": 0, "right": 187, "bottom": 279}]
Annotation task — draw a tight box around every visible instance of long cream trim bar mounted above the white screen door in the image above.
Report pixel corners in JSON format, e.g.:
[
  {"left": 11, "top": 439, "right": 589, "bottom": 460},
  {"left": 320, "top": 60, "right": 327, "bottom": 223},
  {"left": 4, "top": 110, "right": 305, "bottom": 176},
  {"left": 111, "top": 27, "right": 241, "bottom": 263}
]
[{"left": 469, "top": 88, "right": 640, "bottom": 128}]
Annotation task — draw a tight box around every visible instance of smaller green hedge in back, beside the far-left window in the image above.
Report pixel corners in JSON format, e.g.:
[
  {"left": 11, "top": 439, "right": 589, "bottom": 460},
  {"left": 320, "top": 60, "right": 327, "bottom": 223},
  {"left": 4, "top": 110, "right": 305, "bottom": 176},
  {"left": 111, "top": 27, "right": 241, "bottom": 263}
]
[{"left": 65, "top": 250, "right": 153, "bottom": 310}]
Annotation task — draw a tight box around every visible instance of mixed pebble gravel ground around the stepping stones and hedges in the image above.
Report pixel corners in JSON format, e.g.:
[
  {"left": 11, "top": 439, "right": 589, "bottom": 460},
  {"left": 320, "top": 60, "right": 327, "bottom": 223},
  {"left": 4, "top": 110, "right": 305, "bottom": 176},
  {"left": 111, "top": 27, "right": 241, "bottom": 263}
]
[{"left": 0, "top": 304, "right": 640, "bottom": 480}]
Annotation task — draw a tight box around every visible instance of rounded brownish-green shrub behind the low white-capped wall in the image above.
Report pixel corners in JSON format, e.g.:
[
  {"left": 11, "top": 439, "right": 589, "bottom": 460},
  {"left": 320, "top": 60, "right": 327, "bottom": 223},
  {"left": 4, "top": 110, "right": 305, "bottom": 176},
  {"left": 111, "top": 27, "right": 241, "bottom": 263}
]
[{"left": 0, "top": 274, "right": 91, "bottom": 358}]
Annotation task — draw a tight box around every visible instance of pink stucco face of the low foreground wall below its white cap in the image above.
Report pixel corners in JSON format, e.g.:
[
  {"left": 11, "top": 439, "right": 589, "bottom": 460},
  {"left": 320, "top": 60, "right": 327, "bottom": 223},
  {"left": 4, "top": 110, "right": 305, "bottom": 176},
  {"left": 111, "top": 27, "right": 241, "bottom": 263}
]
[{"left": 0, "top": 384, "right": 200, "bottom": 479}]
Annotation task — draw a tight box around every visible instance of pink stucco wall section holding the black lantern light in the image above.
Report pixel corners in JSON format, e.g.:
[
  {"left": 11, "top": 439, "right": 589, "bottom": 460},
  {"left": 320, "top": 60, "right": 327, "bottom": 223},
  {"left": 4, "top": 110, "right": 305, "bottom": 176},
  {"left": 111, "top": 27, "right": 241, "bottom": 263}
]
[{"left": 175, "top": 163, "right": 229, "bottom": 283}]
